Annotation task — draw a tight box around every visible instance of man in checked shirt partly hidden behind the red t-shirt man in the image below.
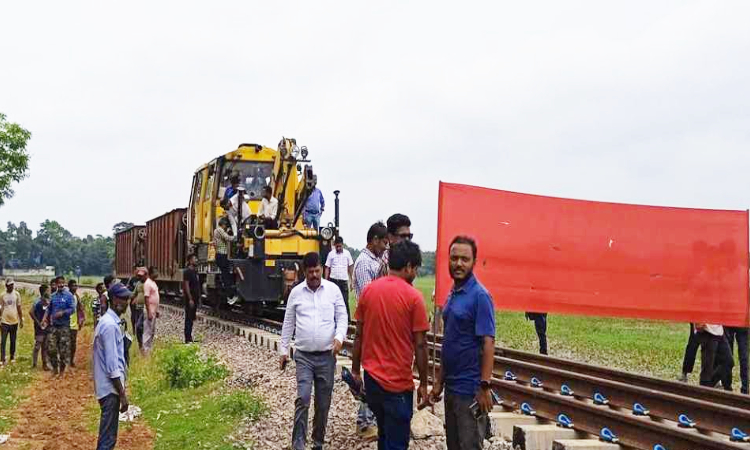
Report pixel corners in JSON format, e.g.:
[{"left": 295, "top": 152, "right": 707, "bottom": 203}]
[{"left": 354, "top": 222, "right": 388, "bottom": 440}]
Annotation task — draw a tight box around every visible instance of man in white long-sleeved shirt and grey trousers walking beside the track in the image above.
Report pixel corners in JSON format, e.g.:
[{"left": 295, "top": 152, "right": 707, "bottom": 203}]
[{"left": 279, "top": 253, "right": 349, "bottom": 450}]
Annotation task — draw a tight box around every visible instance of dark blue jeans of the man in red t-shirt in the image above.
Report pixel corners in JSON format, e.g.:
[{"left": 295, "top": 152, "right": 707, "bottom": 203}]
[{"left": 365, "top": 372, "right": 414, "bottom": 450}]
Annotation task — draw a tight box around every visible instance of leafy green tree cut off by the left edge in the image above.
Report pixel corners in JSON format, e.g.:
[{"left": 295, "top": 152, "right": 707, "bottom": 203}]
[{"left": 0, "top": 113, "right": 31, "bottom": 206}]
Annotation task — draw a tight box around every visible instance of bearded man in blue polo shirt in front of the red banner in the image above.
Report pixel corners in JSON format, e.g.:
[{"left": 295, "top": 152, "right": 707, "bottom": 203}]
[{"left": 428, "top": 236, "right": 495, "bottom": 450}]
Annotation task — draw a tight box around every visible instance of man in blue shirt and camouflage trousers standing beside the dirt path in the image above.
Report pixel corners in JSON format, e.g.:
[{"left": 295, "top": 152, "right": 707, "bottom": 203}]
[{"left": 42, "top": 276, "right": 75, "bottom": 376}]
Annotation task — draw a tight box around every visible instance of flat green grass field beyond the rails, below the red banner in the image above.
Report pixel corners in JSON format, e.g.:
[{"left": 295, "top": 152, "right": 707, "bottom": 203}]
[{"left": 350, "top": 277, "right": 704, "bottom": 387}]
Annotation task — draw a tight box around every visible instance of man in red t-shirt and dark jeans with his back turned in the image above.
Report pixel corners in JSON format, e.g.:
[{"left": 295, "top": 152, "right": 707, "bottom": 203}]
[{"left": 352, "top": 240, "right": 430, "bottom": 450}]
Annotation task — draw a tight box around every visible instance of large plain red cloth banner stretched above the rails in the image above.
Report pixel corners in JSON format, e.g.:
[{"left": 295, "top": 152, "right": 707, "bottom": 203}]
[{"left": 436, "top": 183, "right": 749, "bottom": 326}]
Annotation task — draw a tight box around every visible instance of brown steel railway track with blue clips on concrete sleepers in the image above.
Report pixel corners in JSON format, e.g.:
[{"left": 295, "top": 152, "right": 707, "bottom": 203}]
[{"left": 11, "top": 280, "right": 750, "bottom": 450}]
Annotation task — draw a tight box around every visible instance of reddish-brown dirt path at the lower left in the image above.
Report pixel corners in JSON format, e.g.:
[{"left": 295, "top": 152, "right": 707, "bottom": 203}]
[{"left": 2, "top": 328, "right": 154, "bottom": 450}]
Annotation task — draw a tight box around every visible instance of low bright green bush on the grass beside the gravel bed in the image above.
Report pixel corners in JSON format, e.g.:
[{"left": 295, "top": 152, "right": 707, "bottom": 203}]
[{"left": 159, "top": 344, "right": 229, "bottom": 389}]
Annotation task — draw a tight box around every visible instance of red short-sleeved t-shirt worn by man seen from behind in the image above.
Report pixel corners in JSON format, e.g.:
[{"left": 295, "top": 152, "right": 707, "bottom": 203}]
[{"left": 355, "top": 276, "right": 430, "bottom": 393}]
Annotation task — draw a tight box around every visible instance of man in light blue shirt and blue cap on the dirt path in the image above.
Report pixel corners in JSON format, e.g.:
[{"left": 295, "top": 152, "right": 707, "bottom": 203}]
[{"left": 97, "top": 283, "right": 132, "bottom": 450}]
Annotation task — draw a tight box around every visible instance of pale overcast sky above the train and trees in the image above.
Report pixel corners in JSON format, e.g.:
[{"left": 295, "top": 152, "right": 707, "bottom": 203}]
[{"left": 0, "top": 0, "right": 750, "bottom": 249}]
